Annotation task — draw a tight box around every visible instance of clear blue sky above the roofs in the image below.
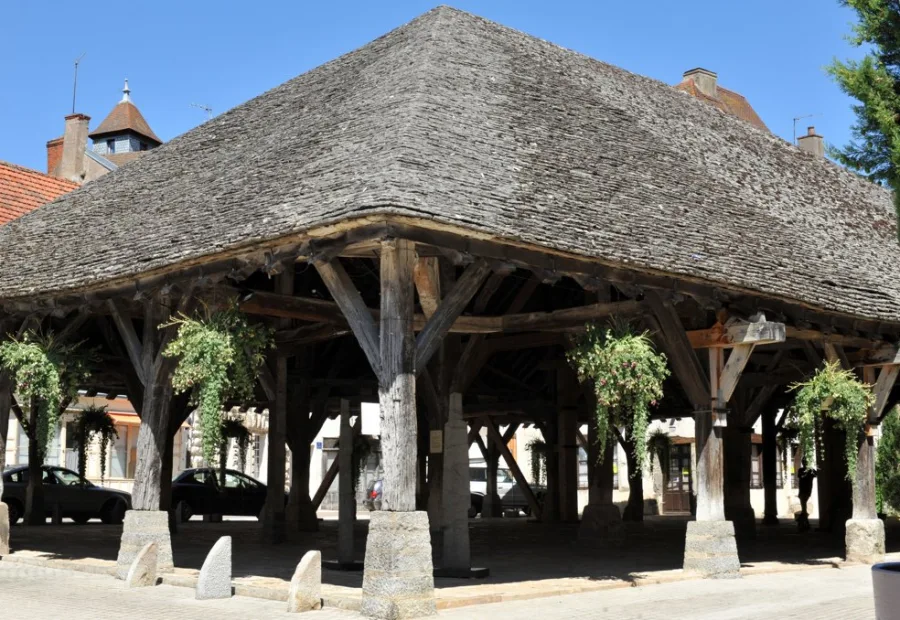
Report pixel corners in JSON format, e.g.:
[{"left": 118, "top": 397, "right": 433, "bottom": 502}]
[{"left": 0, "top": 0, "right": 860, "bottom": 170}]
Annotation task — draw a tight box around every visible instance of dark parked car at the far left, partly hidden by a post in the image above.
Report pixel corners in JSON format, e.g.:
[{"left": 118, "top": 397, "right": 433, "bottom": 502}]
[{"left": 3, "top": 465, "right": 131, "bottom": 525}]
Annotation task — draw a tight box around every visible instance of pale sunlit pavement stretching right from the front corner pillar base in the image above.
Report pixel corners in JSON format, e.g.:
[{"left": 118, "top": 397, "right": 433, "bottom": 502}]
[{"left": 441, "top": 566, "right": 875, "bottom": 620}]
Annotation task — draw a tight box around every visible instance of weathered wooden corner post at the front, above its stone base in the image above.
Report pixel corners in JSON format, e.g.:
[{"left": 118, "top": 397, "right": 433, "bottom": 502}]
[{"left": 378, "top": 239, "right": 417, "bottom": 512}]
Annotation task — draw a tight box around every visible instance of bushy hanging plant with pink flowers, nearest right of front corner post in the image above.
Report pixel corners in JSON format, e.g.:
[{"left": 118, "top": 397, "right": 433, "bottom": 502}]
[{"left": 566, "top": 321, "right": 669, "bottom": 470}]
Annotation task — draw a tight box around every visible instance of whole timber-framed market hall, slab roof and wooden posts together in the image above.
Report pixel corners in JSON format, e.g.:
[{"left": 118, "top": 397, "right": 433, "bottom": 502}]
[{"left": 0, "top": 7, "right": 900, "bottom": 617}]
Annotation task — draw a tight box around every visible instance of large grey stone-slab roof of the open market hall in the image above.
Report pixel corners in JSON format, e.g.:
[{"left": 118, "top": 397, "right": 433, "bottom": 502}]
[{"left": 0, "top": 7, "right": 900, "bottom": 322}]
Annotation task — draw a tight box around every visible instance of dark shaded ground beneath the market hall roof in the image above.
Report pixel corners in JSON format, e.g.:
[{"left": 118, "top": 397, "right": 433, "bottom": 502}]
[{"left": 5, "top": 516, "right": 900, "bottom": 588}]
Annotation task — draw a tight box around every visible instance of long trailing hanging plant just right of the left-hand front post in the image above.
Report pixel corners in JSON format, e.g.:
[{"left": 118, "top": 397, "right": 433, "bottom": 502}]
[{"left": 160, "top": 306, "right": 273, "bottom": 463}]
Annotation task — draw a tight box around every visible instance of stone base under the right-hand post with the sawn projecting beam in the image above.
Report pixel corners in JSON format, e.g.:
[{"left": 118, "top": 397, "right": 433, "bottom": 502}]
[{"left": 684, "top": 521, "right": 741, "bottom": 578}]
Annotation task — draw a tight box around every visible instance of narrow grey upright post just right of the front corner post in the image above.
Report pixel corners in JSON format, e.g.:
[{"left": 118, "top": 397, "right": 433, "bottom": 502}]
[{"left": 442, "top": 392, "right": 468, "bottom": 573}]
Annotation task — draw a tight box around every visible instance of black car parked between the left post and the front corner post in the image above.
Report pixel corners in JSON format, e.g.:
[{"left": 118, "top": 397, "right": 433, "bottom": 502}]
[{"left": 172, "top": 467, "right": 274, "bottom": 521}]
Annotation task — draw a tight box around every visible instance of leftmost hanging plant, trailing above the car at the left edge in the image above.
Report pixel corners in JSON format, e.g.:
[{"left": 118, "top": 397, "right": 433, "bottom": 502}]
[{"left": 0, "top": 330, "right": 94, "bottom": 462}]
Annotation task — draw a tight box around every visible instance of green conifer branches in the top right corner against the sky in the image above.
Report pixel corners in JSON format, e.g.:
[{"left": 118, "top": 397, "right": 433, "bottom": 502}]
[{"left": 828, "top": 0, "right": 900, "bottom": 234}]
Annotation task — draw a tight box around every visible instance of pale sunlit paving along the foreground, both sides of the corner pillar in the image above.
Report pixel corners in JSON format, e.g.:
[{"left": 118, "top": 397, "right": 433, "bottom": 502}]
[{"left": 0, "top": 562, "right": 874, "bottom": 620}]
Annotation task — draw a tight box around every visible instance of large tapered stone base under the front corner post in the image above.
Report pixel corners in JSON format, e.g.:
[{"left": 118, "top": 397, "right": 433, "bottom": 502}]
[{"left": 360, "top": 511, "right": 437, "bottom": 620}]
